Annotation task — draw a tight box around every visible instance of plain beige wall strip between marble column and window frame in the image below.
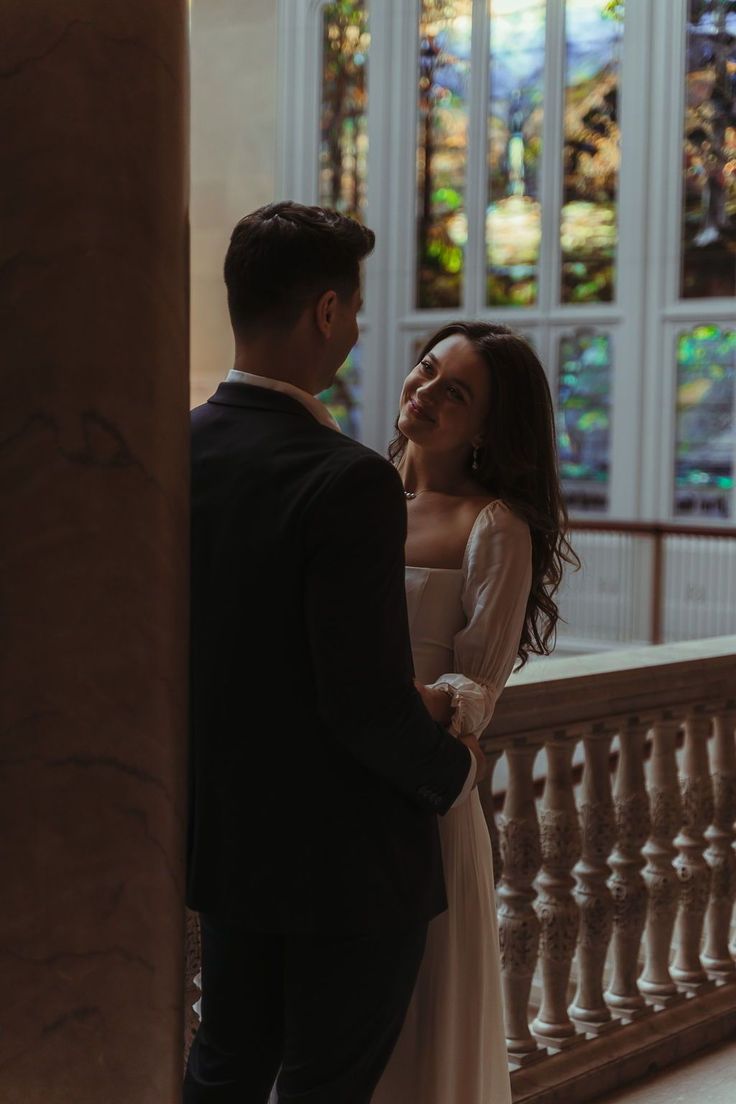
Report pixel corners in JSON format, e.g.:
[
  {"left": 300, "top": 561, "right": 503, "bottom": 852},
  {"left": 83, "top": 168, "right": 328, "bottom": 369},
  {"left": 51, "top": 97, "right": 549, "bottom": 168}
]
[{"left": 191, "top": 0, "right": 278, "bottom": 406}]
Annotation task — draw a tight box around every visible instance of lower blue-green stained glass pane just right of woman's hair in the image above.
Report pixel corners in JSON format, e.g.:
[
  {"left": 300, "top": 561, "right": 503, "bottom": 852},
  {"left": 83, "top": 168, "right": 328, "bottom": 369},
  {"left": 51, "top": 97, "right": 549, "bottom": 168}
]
[{"left": 557, "top": 330, "right": 612, "bottom": 511}]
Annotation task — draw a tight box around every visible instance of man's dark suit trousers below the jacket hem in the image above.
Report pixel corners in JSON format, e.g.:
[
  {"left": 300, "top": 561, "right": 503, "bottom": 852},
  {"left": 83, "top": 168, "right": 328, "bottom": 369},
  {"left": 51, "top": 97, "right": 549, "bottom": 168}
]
[{"left": 183, "top": 915, "right": 427, "bottom": 1104}]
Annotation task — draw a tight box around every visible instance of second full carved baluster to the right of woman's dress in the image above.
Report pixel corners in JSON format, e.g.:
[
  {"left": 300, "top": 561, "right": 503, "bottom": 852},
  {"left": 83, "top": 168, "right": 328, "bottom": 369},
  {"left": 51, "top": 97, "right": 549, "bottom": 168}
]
[{"left": 532, "top": 736, "right": 582, "bottom": 1048}]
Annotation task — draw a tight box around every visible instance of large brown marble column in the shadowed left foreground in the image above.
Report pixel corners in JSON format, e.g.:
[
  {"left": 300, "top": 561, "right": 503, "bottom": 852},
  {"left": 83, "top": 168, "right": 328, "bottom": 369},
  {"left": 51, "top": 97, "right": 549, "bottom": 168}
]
[{"left": 0, "top": 0, "right": 188, "bottom": 1104}]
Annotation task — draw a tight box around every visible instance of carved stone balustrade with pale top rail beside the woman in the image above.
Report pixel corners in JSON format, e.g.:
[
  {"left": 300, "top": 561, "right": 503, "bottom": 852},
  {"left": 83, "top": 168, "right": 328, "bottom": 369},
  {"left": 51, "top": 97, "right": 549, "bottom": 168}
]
[{"left": 483, "top": 637, "right": 736, "bottom": 1104}]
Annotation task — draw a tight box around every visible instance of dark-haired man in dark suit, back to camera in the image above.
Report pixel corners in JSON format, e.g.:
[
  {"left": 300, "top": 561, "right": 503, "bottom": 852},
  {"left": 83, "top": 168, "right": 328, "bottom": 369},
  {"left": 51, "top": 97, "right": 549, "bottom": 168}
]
[{"left": 184, "top": 203, "right": 483, "bottom": 1104}]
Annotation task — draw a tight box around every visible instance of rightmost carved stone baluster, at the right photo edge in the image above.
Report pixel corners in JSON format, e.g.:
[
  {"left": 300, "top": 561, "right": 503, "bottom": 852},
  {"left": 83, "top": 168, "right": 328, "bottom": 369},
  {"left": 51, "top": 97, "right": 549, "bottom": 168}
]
[{"left": 703, "top": 710, "right": 736, "bottom": 980}]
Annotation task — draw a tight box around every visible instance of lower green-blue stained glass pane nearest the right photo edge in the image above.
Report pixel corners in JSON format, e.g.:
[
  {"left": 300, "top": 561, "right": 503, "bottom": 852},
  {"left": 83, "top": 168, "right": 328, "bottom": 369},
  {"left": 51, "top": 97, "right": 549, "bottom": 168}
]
[{"left": 674, "top": 326, "right": 736, "bottom": 518}]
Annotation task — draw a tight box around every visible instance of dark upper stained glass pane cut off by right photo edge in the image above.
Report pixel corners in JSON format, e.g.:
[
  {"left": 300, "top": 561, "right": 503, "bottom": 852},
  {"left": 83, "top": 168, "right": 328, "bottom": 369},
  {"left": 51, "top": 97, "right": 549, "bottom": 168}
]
[{"left": 681, "top": 0, "right": 736, "bottom": 299}]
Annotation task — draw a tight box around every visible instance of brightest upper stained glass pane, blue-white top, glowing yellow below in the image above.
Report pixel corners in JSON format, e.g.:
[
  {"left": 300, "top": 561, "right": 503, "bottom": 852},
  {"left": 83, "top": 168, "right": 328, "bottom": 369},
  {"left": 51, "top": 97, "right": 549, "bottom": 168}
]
[{"left": 486, "top": 0, "right": 546, "bottom": 306}]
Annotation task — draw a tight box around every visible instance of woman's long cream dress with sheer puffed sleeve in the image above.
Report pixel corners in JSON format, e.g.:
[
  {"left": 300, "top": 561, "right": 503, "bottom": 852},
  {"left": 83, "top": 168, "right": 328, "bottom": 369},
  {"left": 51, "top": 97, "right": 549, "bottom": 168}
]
[{"left": 372, "top": 502, "right": 532, "bottom": 1104}]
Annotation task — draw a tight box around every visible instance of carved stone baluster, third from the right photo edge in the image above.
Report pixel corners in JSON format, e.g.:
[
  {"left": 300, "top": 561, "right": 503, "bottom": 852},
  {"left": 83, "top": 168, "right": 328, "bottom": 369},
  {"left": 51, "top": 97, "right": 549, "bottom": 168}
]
[{"left": 639, "top": 719, "right": 684, "bottom": 1006}]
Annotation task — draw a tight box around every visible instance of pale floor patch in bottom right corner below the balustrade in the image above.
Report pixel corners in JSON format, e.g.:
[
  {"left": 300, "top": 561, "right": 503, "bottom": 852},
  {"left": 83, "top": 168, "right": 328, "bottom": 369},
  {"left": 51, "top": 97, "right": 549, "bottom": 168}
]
[{"left": 596, "top": 1040, "right": 736, "bottom": 1104}]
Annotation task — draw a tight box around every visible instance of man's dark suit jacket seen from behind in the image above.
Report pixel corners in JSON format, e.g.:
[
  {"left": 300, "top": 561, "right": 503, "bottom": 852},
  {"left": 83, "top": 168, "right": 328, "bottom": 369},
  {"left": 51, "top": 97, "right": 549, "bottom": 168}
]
[{"left": 188, "top": 383, "right": 470, "bottom": 934}]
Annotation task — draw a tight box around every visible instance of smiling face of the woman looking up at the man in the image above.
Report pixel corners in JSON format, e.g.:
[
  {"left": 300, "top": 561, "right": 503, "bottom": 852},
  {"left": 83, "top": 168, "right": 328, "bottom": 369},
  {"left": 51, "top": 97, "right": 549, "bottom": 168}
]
[{"left": 398, "top": 333, "right": 490, "bottom": 452}]
